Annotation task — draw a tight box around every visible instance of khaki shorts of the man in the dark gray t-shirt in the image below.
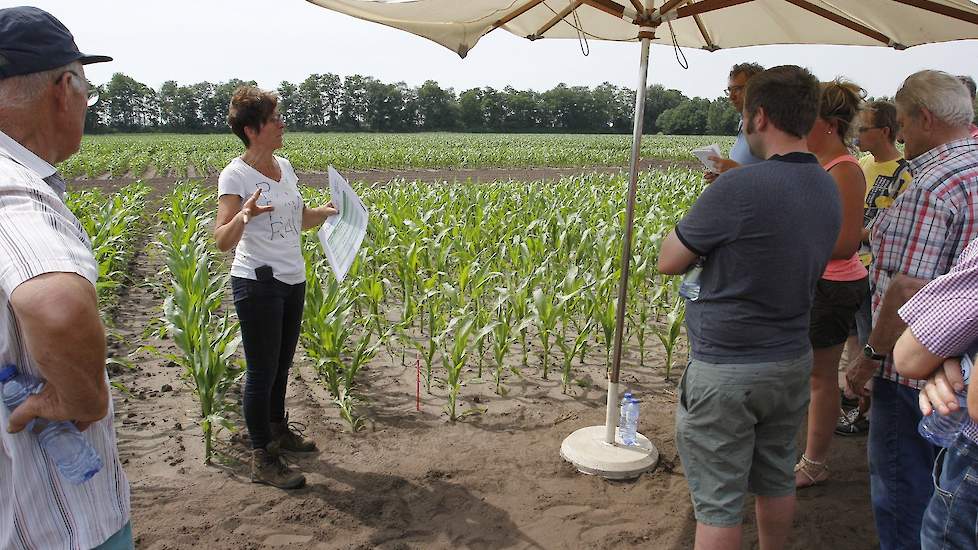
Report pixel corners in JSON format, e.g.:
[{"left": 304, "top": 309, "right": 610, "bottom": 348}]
[{"left": 676, "top": 352, "right": 812, "bottom": 527}]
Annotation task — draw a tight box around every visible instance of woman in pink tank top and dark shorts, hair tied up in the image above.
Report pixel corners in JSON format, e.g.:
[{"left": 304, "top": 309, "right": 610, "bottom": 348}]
[{"left": 795, "top": 80, "right": 869, "bottom": 488}]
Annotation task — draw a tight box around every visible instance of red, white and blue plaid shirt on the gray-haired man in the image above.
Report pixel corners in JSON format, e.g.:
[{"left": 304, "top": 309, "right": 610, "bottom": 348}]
[{"left": 870, "top": 138, "right": 978, "bottom": 388}]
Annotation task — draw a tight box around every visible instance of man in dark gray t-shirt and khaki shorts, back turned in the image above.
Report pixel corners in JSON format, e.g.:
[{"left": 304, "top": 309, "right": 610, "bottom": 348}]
[{"left": 659, "top": 66, "right": 842, "bottom": 548}]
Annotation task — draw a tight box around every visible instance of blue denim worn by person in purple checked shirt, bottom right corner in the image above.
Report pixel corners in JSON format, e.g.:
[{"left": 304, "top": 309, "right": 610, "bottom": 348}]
[{"left": 920, "top": 434, "right": 978, "bottom": 550}]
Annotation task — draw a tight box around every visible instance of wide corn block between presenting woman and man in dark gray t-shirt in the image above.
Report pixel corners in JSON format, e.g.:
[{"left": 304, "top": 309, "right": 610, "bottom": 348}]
[{"left": 302, "top": 170, "right": 702, "bottom": 430}]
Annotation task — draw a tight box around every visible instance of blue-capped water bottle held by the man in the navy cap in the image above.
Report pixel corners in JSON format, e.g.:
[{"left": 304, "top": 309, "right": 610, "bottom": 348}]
[{"left": 0, "top": 365, "right": 102, "bottom": 485}]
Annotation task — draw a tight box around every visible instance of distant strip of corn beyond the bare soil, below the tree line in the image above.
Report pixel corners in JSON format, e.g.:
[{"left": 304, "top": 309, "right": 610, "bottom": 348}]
[{"left": 59, "top": 133, "right": 733, "bottom": 178}]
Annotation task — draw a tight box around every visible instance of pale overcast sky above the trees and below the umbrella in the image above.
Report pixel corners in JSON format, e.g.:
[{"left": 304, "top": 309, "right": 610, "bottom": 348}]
[{"left": 21, "top": 0, "right": 978, "bottom": 98}]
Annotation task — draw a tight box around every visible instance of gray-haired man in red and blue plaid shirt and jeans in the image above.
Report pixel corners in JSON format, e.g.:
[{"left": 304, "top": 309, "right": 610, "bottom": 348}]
[{"left": 846, "top": 71, "right": 978, "bottom": 550}]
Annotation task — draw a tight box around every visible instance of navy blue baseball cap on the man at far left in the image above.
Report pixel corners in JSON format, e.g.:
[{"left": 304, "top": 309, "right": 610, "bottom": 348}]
[{"left": 0, "top": 6, "right": 112, "bottom": 78}]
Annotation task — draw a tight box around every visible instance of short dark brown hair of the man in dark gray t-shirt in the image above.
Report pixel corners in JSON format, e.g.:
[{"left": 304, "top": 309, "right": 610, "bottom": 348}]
[{"left": 744, "top": 65, "right": 820, "bottom": 138}]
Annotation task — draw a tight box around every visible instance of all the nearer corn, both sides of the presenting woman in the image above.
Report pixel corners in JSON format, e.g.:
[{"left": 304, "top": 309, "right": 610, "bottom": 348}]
[{"left": 76, "top": 169, "right": 702, "bottom": 461}]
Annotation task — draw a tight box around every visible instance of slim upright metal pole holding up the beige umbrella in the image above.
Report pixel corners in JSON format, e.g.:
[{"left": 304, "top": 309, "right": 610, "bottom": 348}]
[{"left": 604, "top": 32, "right": 651, "bottom": 443}]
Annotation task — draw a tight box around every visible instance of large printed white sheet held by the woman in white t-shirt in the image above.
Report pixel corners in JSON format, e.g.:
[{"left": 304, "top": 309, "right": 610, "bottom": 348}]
[{"left": 319, "top": 166, "right": 367, "bottom": 283}]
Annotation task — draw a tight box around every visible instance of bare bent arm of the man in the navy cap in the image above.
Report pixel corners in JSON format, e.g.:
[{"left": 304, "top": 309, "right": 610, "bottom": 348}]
[{"left": 8, "top": 273, "right": 109, "bottom": 432}]
